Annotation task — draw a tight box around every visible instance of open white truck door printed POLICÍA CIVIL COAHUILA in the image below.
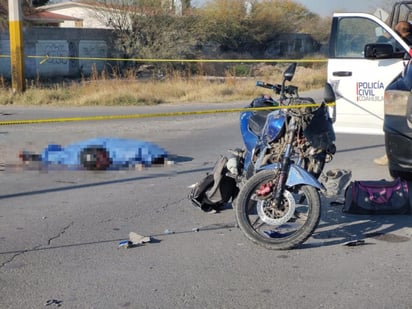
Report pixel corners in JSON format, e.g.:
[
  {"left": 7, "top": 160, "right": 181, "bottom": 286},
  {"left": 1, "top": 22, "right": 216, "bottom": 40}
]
[{"left": 328, "top": 13, "right": 410, "bottom": 134}]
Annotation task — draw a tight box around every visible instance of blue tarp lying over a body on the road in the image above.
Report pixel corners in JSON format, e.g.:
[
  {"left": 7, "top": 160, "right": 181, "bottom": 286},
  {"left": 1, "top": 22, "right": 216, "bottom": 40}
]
[{"left": 41, "top": 138, "right": 167, "bottom": 166}]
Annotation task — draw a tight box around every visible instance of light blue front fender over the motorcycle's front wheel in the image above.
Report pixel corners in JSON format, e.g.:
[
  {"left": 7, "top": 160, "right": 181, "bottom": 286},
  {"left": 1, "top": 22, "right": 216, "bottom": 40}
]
[{"left": 257, "top": 163, "right": 325, "bottom": 190}]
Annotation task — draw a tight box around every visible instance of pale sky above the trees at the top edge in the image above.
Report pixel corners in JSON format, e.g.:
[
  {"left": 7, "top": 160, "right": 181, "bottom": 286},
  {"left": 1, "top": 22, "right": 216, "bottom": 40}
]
[{"left": 192, "top": 0, "right": 388, "bottom": 16}]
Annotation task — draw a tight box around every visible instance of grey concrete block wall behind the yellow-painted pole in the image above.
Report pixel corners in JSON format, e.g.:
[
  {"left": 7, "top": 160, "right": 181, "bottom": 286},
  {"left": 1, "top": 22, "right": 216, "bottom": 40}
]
[{"left": 0, "top": 28, "right": 116, "bottom": 78}]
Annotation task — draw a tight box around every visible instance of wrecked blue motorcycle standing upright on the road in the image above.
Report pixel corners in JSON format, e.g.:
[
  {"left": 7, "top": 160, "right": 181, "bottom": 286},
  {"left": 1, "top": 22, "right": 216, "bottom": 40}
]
[{"left": 228, "top": 63, "right": 336, "bottom": 250}]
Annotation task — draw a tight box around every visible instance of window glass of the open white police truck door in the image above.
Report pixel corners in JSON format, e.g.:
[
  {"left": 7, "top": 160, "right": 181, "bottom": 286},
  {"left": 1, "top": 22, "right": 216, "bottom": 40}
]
[{"left": 335, "top": 17, "right": 396, "bottom": 58}]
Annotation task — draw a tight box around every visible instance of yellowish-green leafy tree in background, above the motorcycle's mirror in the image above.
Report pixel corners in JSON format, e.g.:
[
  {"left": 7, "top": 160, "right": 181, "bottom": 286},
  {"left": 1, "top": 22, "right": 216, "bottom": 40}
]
[{"left": 200, "top": 0, "right": 317, "bottom": 52}]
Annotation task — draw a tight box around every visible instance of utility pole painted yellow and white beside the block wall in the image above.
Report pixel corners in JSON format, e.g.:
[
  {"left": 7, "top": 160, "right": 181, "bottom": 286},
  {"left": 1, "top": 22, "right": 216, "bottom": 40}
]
[{"left": 9, "top": 0, "right": 25, "bottom": 93}]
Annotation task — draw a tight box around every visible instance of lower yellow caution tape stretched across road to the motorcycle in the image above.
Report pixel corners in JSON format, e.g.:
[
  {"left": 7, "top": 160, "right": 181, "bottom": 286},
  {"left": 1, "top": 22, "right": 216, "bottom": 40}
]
[{"left": 0, "top": 103, "right": 335, "bottom": 126}]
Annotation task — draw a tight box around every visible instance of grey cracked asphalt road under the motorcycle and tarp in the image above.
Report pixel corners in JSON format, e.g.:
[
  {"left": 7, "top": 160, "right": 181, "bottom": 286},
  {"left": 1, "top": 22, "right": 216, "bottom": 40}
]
[{"left": 0, "top": 103, "right": 412, "bottom": 308}]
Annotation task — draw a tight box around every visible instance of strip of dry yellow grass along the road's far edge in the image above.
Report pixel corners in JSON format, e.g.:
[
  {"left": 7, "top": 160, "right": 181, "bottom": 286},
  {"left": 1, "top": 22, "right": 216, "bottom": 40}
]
[{"left": 0, "top": 64, "right": 326, "bottom": 106}]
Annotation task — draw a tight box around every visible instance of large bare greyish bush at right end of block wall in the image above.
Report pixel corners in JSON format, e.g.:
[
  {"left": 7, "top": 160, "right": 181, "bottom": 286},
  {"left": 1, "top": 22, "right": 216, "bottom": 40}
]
[{"left": 84, "top": 0, "right": 201, "bottom": 71}]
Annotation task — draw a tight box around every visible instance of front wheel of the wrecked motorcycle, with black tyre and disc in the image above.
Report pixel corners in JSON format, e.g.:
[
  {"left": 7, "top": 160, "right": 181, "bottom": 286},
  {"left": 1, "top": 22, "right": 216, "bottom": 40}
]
[{"left": 235, "top": 170, "right": 321, "bottom": 250}]
